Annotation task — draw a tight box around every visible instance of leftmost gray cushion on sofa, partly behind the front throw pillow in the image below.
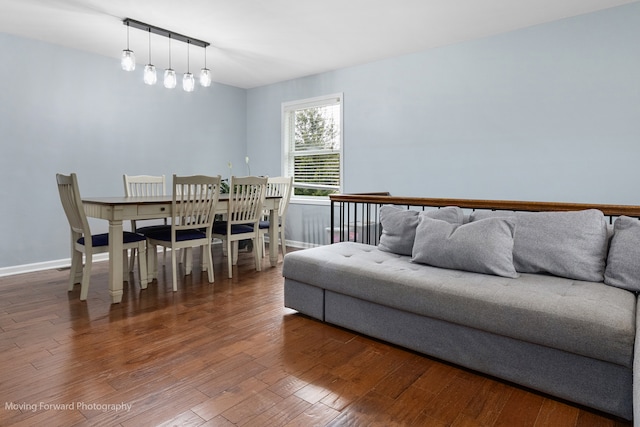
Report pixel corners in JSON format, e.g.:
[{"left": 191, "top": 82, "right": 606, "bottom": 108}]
[{"left": 378, "top": 205, "right": 464, "bottom": 255}]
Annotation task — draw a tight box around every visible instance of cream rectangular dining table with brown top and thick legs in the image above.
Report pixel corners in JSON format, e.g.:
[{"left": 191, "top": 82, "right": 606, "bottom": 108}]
[{"left": 82, "top": 194, "right": 281, "bottom": 304}]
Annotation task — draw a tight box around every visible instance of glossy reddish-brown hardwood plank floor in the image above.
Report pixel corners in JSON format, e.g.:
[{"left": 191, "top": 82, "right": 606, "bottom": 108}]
[{"left": 0, "top": 246, "right": 631, "bottom": 427}]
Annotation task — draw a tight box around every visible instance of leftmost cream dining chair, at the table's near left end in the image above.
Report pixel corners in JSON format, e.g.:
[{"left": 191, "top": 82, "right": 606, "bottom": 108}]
[{"left": 56, "top": 173, "right": 147, "bottom": 301}]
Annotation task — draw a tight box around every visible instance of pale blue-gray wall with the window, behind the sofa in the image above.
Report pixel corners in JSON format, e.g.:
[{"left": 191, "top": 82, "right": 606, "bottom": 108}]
[{"left": 247, "top": 3, "right": 640, "bottom": 247}]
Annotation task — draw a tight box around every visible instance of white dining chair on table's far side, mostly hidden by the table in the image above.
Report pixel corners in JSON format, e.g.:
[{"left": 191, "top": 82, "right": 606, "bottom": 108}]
[{"left": 122, "top": 174, "right": 171, "bottom": 271}]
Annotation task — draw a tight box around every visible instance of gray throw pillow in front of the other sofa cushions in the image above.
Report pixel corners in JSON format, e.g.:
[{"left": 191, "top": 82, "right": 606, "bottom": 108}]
[{"left": 411, "top": 216, "right": 518, "bottom": 278}]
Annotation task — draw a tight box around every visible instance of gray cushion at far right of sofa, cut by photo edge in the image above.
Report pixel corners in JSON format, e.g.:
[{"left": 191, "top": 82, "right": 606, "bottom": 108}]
[{"left": 604, "top": 216, "right": 640, "bottom": 291}]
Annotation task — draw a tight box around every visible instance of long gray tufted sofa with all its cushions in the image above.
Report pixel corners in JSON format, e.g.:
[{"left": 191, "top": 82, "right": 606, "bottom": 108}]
[{"left": 283, "top": 206, "right": 640, "bottom": 420}]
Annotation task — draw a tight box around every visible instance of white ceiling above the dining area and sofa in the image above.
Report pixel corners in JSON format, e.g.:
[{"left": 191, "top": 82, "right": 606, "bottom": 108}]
[{"left": 0, "top": 0, "right": 638, "bottom": 88}]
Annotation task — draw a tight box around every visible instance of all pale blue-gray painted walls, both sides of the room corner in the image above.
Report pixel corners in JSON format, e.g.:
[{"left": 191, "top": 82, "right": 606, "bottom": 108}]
[{"left": 0, "top": 3, "right": 640, "bottom": 268}]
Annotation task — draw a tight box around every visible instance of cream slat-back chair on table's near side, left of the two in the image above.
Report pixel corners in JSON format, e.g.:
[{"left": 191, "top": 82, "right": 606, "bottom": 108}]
[{"left": 147, "top": 175, "right": 220, "bottom": 292}]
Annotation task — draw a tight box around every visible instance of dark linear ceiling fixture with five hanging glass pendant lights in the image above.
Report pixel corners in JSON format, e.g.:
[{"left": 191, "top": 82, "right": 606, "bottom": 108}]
[{"left": 122, "top": 18, "right": 211, "bottom": 92}]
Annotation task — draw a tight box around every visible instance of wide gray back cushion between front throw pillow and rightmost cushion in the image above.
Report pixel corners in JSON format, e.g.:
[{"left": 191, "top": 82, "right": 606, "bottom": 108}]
[{"left": 471, "top": 209, "right": 608, "bottom": 282}]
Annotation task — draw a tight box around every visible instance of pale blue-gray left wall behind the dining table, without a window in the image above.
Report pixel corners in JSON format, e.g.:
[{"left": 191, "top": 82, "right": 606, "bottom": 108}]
[{"left": 0, "top": 33, "right": 246, "bottom": 268}]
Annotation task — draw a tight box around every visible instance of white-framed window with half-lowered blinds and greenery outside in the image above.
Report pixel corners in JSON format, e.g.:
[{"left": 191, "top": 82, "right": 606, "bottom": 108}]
[{"left": 282, "top": 94, "right": 342, "bottom": 199}]
